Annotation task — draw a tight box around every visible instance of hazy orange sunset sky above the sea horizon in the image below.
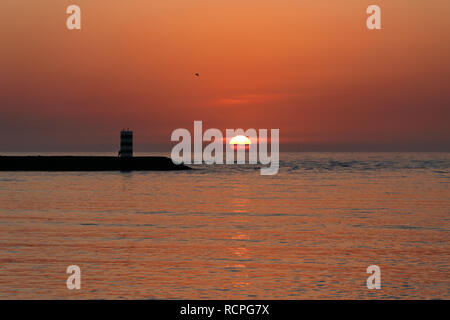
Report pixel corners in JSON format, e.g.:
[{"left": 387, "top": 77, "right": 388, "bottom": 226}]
[{"left": 0, "top": 0, "right": 450, "bottom": 152}]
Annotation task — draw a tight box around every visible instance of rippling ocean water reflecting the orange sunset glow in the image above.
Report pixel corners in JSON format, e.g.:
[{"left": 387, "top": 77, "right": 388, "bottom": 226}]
[{"left": 0, "top": 153, "right": 450, "bottom": 299}]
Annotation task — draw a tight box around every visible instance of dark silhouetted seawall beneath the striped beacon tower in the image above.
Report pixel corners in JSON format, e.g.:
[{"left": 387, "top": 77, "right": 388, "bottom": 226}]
[{"left": 0, "top": 156, "right": 191, "bottom": 171}]
